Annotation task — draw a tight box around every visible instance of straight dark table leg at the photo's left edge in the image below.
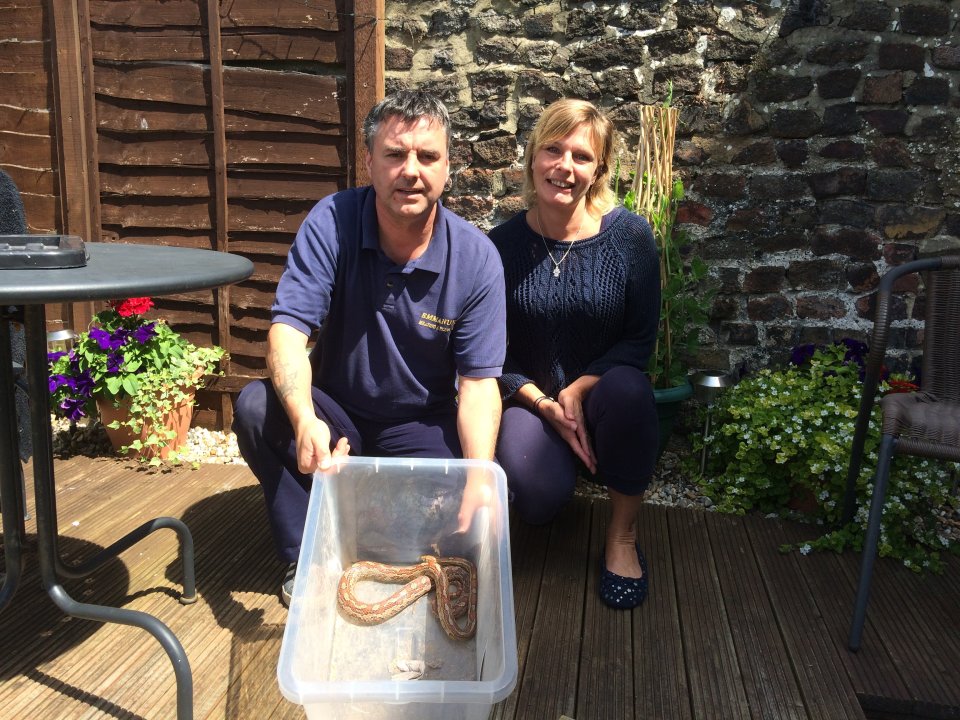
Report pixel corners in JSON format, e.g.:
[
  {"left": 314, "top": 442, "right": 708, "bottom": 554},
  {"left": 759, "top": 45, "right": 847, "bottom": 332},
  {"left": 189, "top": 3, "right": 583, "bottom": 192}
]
[{"left": 0, "top": 317, "right": 25, "bottom": 611}]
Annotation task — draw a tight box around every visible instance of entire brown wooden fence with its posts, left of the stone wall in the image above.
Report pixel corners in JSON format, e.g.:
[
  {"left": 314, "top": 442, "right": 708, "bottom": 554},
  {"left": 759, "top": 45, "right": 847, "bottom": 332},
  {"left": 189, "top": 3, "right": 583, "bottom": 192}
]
[{"left": 0, "top": 0, "right": 384, "bottom": 425}]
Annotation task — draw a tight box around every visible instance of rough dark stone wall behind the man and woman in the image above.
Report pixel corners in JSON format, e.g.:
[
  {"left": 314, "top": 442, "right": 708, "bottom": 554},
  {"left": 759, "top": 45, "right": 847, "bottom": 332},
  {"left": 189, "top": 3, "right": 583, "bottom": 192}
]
[{"left": 386, "top": 0, "right": 960, "bottom": 369}]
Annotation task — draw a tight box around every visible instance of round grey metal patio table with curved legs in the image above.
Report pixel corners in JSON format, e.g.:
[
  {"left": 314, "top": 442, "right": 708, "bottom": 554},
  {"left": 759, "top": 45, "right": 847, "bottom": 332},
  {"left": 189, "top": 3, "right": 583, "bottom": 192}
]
[{"left": 0, "top": 243, "right": 253, "bottom": 720}]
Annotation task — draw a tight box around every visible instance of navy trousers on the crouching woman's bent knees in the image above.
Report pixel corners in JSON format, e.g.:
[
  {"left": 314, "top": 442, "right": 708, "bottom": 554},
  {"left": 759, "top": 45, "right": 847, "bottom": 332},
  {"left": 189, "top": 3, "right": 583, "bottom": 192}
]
[{"left": 497, "top": 365, "right": 659, "bottom": 524}]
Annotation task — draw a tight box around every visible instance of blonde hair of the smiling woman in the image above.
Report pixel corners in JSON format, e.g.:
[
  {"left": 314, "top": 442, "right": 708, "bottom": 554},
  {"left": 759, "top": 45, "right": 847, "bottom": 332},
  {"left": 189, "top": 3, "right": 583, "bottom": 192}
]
[{"left": 523, "top": 98, "right": 617, "bottom": 215}]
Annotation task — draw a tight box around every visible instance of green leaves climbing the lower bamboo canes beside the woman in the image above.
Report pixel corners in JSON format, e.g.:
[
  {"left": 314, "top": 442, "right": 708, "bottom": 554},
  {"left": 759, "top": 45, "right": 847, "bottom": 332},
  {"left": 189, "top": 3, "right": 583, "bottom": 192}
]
[{"left": 623, "top": 178, "right": 714, "bottom": 388}]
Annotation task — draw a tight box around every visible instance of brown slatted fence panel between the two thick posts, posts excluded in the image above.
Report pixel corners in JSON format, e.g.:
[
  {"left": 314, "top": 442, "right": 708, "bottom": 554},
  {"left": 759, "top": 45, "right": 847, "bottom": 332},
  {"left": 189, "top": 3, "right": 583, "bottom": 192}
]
[{"left": 81, "top": 0, "right": 355, "bottom": 421}]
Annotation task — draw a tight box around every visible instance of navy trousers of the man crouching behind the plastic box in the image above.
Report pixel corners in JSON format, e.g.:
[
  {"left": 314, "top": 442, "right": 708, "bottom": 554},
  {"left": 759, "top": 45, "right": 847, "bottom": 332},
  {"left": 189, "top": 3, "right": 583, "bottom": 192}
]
[{"left": 233, "top": 380, "right": 462, "bottom": 563}]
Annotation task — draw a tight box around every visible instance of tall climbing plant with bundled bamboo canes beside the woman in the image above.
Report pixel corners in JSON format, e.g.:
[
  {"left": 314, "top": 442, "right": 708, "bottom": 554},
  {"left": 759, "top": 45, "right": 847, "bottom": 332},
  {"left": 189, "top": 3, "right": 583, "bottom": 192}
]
[{"left": 624, "top": 99, "right": 713, "bottom": 452}]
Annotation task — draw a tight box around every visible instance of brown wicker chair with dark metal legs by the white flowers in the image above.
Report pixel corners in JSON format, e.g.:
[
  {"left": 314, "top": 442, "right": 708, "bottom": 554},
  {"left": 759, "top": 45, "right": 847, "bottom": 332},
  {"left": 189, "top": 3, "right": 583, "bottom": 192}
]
[{"left": 844, "top": 256, "right": 960, "bottom": 650}]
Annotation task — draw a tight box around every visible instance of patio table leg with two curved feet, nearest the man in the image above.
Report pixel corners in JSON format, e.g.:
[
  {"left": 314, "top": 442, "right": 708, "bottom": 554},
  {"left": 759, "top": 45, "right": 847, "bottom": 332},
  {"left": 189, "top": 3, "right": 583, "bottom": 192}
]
[{"left": 25, "top": 305, "right": 196, "bottom": 720}]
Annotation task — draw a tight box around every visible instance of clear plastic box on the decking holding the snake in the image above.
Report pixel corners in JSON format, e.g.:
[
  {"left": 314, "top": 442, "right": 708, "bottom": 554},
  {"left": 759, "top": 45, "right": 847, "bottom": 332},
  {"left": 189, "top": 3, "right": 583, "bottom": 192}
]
[{"left": 277, "top": 457, "right": 517, "bottom": 720}]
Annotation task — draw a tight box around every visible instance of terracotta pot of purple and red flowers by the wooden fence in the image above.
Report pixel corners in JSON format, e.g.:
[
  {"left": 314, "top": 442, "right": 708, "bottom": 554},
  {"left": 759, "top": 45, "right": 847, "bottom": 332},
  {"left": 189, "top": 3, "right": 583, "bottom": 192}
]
[{"left": 48, "top": 298, "right": 224, "bottom": 465}]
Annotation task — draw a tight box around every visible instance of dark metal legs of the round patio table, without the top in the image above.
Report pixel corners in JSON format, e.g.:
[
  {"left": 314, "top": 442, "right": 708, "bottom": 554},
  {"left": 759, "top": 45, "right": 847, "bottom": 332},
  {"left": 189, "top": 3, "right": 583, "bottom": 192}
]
[{"left": 0, "top": 305, "right": 197, "bottom": 720}]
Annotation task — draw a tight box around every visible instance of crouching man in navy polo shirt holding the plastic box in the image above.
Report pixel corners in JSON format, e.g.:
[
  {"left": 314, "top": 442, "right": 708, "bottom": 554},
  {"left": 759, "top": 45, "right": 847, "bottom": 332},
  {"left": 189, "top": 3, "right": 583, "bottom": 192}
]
[{"left": 233, "top": 90, "right": 506, "bottom": 604}]
